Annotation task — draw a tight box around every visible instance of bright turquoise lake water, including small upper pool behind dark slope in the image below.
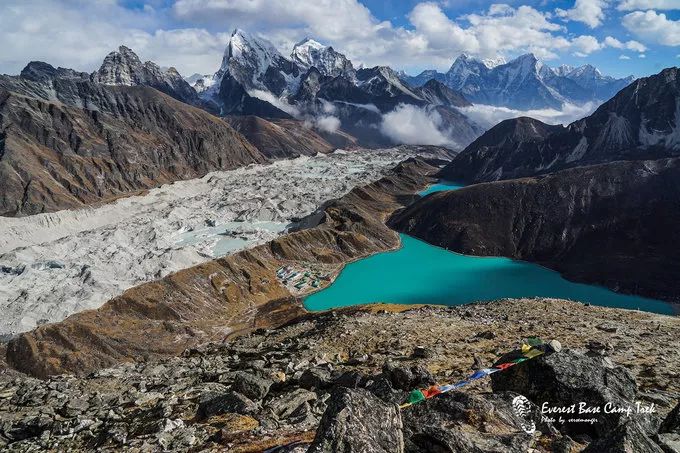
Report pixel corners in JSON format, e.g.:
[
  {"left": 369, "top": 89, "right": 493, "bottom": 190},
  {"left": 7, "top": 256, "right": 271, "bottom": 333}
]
[{"left": 304, "top": 182, "right": 674, "bottom": 314}]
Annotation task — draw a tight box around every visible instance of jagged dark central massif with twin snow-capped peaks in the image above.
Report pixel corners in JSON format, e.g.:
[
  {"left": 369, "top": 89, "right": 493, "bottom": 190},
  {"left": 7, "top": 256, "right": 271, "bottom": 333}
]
[{"left": 196, "top": 29, "right": 482, "bottom": 147}]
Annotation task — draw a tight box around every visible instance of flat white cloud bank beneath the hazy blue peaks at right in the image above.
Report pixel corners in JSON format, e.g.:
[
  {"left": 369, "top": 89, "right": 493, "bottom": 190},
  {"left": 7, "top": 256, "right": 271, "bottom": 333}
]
[{"left": 460, "top": 102, "right": 597, "bottom": 128}]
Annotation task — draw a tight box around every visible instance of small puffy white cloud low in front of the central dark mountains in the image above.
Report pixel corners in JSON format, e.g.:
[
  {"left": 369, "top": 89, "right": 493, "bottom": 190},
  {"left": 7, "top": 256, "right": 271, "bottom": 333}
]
[{"left": 380, "top": 104, "right": 457, "bottom": 147}]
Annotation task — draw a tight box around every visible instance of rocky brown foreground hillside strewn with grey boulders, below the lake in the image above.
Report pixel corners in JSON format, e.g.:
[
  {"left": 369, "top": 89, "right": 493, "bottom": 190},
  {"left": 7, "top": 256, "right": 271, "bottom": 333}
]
[{"left": 0, "top": 299, "right": 680, "bottom": 452}]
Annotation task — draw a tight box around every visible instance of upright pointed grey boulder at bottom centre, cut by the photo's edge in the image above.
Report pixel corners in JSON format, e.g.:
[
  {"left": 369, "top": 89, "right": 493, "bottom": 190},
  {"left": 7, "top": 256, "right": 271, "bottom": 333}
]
[{"left": 308, "top": 388, "right": 404, "bottom": 453}]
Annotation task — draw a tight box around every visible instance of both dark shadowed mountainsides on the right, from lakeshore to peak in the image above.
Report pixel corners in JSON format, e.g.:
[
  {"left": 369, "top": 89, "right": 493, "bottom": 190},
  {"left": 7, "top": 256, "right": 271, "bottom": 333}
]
[{"left": 391, "top": 68, "right": 680, "bottom": 306}]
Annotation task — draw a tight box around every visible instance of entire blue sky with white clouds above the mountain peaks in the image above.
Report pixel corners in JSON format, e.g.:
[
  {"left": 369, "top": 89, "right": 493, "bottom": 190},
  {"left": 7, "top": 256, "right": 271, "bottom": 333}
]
[{"left": 0, "top": 0, "right": 680, "bottom": 76}]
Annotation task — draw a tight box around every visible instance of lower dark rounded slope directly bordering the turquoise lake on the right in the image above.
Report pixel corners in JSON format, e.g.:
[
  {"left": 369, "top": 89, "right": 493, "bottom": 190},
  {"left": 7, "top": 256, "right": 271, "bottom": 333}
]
[{"left": 392, "top": 158, "right": 680, "bottom": 302}]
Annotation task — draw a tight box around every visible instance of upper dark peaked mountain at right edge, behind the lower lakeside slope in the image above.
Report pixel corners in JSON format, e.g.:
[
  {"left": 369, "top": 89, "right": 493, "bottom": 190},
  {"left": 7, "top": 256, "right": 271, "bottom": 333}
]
[{"left": 442, "top": 68, "right": 680, "bottom": 182}]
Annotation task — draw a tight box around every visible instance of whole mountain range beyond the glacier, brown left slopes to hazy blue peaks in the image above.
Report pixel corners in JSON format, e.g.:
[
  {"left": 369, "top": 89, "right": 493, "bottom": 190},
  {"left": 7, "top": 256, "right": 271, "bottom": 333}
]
[{"left": 0, "top": 30, "right": 644, "bottom": 215}]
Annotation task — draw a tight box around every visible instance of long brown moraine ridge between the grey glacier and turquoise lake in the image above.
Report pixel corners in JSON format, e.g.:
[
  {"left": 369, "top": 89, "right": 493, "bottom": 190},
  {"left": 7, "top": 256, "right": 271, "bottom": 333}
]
[{"left": 7, "top": 156, "right": 436, "bottom": 377}]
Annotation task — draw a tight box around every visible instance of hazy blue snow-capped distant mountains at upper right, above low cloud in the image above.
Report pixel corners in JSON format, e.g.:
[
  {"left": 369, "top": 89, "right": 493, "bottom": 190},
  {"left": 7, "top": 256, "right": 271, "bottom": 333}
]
[{"left": 402, "top": 54, "right": 634, "bottom": 110}]
